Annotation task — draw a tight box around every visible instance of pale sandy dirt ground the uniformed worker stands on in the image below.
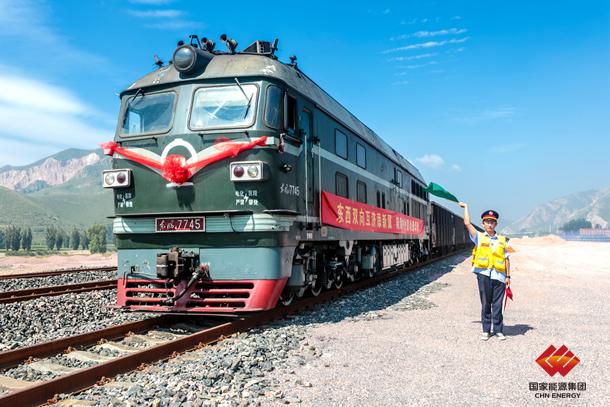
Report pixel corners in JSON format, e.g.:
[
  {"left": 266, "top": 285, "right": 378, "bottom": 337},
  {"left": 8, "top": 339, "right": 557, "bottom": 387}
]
[{"left": 270, "top": 236, "right": 610, "bottom": 406}]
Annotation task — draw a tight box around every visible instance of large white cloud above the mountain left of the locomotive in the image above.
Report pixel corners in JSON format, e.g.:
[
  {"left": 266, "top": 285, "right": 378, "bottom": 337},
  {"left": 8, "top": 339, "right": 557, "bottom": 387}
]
[{"left": 0, "top": 71, "right": 114, "bottom": 166}]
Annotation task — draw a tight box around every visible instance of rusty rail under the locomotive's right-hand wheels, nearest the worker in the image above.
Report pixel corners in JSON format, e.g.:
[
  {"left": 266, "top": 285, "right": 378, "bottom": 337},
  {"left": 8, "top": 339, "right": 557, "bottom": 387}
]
[{"left": 0, "top": 250, "right": 461, "bottom": 407}]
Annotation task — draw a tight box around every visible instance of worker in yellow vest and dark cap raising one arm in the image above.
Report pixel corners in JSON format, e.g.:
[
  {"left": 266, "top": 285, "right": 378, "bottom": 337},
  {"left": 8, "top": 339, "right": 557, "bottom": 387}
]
[{"left": 459, "top": 202, "right": 510, "bottom": 341}]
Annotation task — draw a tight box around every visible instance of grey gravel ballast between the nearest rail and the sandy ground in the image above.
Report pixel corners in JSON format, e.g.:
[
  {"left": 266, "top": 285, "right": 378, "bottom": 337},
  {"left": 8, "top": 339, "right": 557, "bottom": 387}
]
[{"left": 57, "top": 259, "right": 464, "bottom": 406}]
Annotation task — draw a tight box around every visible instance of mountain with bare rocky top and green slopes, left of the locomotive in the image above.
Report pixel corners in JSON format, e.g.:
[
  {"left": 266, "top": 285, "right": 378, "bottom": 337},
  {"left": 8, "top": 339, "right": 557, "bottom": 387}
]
[{"left": 0, "top": 149, "right": 113, "bottom": 229}]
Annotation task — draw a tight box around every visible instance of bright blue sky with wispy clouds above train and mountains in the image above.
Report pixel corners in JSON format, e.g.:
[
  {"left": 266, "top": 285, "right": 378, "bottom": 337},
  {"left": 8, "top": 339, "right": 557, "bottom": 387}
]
[{"left": 0, "top": 0, "right": 610, "bottom": 224}]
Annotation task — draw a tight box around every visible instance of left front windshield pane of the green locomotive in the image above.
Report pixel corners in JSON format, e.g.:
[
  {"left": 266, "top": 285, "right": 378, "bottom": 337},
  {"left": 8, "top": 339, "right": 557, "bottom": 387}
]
[{"left": 121, "top": 91, "right": 176, "bottom": 136}]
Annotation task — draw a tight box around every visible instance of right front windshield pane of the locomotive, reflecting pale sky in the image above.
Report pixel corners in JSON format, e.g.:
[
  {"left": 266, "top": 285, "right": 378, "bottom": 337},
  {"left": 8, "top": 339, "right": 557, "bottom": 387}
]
[{"left": 190, "top": 85, "right": 257, "bottom": 130}]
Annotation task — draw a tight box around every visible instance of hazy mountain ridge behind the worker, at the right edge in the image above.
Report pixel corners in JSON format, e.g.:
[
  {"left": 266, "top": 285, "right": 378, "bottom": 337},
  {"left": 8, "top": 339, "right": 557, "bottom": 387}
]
[{"left": 502, "top": 187, "right": 610, "bottom": 234}]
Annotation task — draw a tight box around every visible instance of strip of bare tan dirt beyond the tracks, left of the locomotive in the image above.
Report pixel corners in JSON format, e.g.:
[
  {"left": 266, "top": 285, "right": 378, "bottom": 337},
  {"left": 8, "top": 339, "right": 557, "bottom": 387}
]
[{"left": 0, "top": 251, "right": 117, "bottom": 275}]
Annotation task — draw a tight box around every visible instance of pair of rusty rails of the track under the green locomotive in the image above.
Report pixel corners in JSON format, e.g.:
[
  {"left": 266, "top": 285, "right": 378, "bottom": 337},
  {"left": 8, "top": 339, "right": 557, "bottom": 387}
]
[{"left": 0, "top": 251, "right": 461, "bottom": 407}]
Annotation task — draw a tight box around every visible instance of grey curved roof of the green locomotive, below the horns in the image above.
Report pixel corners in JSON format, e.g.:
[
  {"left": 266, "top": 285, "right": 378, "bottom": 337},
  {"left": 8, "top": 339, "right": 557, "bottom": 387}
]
[{"left": 129, "top": 54, "right": 425, "bottom": 183}]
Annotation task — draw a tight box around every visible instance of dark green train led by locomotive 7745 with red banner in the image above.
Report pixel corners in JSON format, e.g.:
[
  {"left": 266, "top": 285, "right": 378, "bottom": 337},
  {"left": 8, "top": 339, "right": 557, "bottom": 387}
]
[{"left": 102, "top": 35, "right": 465, "bottom": 313}]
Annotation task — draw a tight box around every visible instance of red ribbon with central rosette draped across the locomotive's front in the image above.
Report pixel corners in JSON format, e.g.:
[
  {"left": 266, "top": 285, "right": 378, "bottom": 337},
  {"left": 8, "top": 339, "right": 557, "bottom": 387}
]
[{"left": 100, "top": 136, "right": 267, "bottom": 185}]
